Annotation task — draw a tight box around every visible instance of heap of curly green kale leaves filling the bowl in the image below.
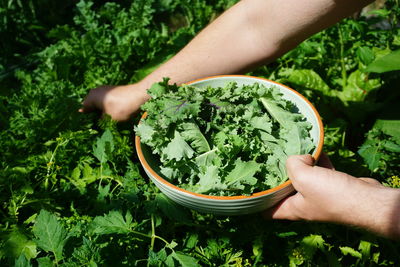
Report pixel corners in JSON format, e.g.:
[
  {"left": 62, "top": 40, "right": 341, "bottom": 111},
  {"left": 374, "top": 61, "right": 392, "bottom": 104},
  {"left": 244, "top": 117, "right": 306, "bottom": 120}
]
[{"left": 135, "top": 79, "right": 315, "bottom": 196}]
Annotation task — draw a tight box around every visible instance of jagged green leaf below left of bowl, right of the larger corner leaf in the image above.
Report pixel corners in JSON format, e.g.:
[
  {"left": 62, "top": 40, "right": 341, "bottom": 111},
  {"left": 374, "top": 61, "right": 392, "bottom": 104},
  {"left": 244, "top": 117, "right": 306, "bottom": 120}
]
[{"left": 89, "top": 210, "right": 134, "bottom": 235}]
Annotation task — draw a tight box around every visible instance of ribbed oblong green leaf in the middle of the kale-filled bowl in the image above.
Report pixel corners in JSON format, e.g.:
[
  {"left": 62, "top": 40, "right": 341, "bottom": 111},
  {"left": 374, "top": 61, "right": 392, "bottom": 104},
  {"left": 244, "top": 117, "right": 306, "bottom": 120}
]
[{"left": 180, "top": 122, "right": 211, "bottom": 153}]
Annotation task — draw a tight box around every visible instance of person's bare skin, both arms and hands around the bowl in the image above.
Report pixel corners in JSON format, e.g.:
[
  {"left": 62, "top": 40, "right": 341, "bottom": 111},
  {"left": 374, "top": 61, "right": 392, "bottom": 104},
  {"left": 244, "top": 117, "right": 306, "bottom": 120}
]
[{"left": 80, "top": 0, "right": 400, "bottom": 238}]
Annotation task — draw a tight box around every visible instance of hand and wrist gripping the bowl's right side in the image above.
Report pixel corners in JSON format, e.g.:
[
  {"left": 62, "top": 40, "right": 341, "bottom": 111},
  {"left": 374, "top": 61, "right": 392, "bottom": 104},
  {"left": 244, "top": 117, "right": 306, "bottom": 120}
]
[{"left": 264, "top": 155, "right": 400, "bottom": 239}]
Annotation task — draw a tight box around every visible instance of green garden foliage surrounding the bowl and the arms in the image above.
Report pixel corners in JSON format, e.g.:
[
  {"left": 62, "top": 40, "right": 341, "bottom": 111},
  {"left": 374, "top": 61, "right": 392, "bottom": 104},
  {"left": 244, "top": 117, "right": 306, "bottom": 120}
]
[{"left": 0, "top": 0, "right": 400, "bottom": 266}]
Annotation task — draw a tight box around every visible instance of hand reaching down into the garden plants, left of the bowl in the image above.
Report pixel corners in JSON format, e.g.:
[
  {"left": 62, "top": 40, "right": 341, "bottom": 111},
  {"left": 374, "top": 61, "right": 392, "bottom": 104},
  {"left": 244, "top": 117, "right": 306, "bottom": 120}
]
[{"left": 79, "top": 84, "right": 150, "bottom": 121}]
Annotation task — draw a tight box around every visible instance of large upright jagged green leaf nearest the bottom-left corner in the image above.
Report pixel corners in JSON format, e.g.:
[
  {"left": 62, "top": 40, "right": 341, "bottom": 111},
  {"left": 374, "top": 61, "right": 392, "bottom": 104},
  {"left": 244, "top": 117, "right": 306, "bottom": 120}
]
[{"left": 33, "top": 210, "right": 67, "bottom": 262}]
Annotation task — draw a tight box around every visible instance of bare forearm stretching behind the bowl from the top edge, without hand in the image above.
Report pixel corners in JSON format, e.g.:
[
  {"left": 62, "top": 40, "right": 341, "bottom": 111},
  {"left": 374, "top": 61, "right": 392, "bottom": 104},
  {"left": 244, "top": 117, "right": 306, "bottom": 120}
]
[{"left": 138, "top": 0, "right": 369, "bottom": 91}]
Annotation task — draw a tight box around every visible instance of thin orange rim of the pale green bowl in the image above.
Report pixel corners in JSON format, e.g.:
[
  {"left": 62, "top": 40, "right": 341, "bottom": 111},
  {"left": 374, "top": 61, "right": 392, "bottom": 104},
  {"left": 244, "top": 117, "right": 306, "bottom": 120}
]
[{"left": 135, "top": 75, "right": 324, "bottom": 200}]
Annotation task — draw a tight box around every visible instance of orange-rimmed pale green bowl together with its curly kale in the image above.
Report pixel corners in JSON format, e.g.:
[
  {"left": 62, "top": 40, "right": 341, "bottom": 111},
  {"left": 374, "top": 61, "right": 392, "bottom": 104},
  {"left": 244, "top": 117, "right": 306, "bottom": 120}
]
[{"left": 135, "top": 75, "right": 324, "bottom": 215}]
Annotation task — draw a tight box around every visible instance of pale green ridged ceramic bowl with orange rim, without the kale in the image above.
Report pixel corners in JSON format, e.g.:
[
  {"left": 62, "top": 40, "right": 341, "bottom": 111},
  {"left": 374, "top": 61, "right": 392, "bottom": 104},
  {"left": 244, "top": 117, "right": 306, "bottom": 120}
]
[{"left": 135, "top": 75, "right": 324, "bottom": 215}]
